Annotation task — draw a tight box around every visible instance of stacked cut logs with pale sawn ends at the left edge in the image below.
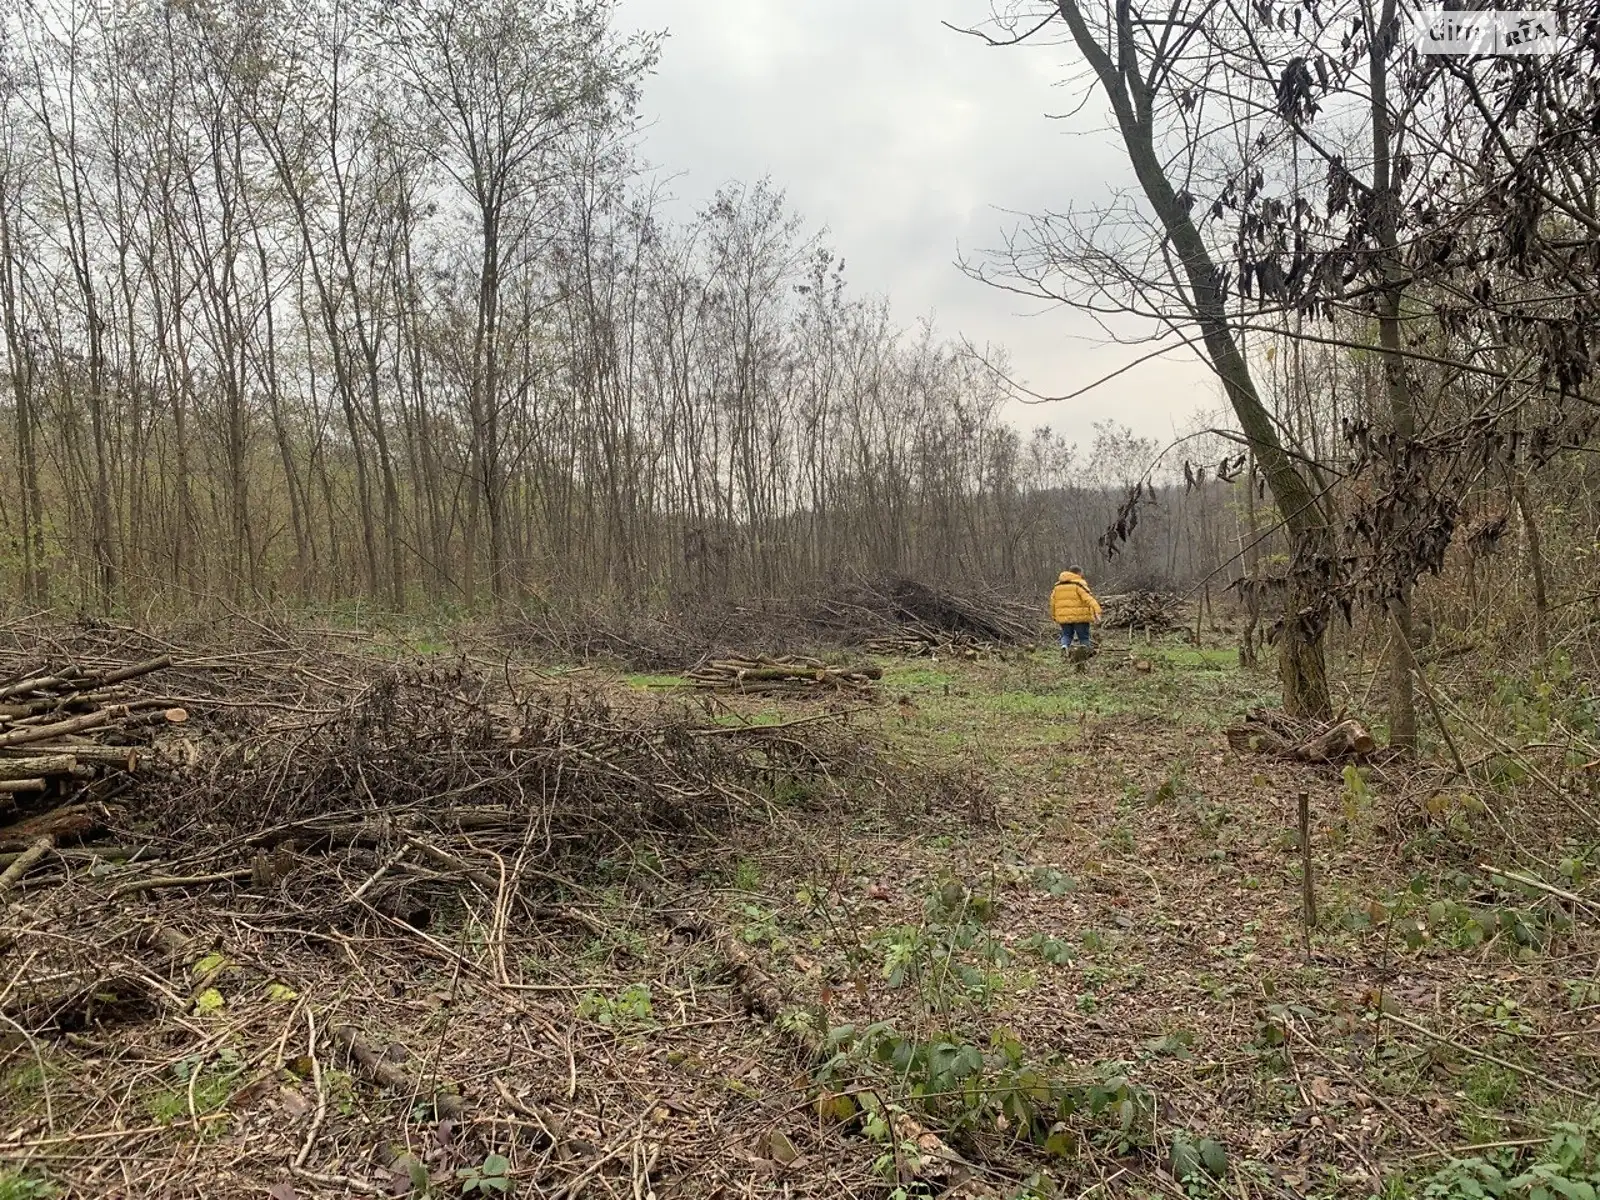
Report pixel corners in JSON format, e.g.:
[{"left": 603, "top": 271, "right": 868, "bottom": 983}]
[{"left": 0, "top": 656, "right": 176, "bottom": 845}]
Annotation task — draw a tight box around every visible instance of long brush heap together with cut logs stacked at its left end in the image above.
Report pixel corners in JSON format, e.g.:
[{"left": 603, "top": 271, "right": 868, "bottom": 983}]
[{"left": 0, "top": 638, "right": 878, "bottom": 902}]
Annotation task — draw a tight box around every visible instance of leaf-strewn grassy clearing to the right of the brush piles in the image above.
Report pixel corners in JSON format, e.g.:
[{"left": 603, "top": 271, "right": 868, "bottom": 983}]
[{"left": 704, "top": 633, "right": 1600, "bottom": 1200}]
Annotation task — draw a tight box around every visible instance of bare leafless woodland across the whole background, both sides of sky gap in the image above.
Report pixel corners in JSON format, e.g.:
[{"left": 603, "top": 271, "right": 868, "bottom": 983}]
[{"left": 0, "top": 0, "right": 1600, "bottom": 707}]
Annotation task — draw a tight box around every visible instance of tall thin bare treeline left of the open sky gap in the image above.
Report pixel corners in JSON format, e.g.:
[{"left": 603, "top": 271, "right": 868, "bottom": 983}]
[{"left": 0, "top": 0, "right": 1238, "bottom": 611}]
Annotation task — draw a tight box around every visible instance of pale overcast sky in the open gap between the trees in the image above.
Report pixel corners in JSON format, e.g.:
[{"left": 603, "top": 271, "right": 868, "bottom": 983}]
[{"left": 621, "top": 0, "right": 1219, "bottom": 443}]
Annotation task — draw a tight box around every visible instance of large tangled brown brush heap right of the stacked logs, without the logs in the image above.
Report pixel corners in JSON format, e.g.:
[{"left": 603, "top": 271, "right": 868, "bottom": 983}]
[{"left": 0, "top": 649, "right": 869, "bottom": 1032}]
